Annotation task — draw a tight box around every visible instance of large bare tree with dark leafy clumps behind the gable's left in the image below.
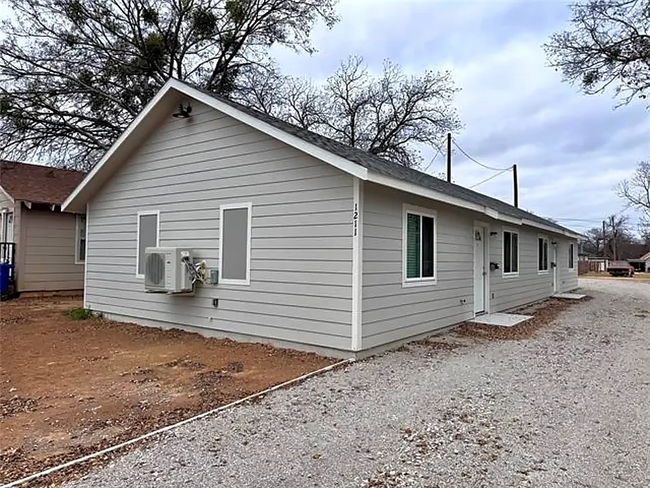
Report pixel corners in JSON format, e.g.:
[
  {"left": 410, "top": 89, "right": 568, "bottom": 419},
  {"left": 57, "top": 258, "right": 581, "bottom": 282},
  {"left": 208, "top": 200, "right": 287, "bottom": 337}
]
[{"left": 0, "top": 0, "right": 337, "bottom": 168}]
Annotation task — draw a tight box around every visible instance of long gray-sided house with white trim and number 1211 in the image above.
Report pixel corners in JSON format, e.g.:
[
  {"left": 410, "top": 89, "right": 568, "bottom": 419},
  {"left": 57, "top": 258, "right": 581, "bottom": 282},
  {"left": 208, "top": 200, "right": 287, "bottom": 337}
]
[{"left": 63, "top": 80, "right": 580, "bottom": 356}]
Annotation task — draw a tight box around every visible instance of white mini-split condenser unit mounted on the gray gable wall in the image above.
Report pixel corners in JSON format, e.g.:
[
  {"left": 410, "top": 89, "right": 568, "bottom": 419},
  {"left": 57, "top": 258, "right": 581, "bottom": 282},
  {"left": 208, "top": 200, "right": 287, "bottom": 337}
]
[{"left": 144, "top": 247, "right": 194, "bottom": 293}]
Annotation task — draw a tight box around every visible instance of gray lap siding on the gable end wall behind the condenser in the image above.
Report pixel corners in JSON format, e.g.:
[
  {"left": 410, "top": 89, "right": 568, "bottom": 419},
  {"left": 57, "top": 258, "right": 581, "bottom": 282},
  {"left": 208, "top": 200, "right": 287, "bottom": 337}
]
[{"left": 86, "top": 103, "right": 352, "bottom": 350}]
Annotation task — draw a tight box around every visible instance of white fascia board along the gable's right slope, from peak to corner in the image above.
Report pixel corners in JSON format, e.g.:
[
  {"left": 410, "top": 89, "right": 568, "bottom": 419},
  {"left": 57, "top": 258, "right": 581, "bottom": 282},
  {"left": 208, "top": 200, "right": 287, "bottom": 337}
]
[{"left": 170, "top": 80, "right": 368, "bottom": 180}]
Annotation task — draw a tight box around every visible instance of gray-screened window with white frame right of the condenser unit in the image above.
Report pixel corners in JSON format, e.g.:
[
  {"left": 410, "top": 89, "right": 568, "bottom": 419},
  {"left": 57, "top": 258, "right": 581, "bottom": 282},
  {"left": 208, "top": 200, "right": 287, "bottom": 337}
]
[{"left": 219, "top": 203, "right": 252, "bottom": 285}]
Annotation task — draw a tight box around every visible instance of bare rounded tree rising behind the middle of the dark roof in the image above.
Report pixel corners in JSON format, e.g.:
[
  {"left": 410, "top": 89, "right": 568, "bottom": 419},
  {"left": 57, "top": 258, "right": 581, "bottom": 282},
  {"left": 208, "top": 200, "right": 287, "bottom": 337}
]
[{"left": 234, "top": 56, "right": 461, "bottom": 167}]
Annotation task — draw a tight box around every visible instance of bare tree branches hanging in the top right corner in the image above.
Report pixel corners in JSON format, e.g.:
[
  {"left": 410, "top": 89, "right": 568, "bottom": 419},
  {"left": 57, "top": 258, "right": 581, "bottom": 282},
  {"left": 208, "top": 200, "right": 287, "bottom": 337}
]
[{"left": 544, "top": 0, "right": 650, "bottom": 104}]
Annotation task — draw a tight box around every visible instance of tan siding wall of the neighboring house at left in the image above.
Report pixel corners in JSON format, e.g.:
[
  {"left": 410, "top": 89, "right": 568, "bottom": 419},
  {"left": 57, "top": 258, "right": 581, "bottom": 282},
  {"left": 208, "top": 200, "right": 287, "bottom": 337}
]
[{"left": 18, "top": 207, "right": 84, "bottom": 292}]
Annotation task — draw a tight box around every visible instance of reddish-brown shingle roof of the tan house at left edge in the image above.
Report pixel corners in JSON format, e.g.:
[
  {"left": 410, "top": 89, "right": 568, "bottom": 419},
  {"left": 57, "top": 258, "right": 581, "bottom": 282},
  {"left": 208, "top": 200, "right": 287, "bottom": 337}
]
[{"left": 0, "top": 161, "right": 86, "bottom": 205}]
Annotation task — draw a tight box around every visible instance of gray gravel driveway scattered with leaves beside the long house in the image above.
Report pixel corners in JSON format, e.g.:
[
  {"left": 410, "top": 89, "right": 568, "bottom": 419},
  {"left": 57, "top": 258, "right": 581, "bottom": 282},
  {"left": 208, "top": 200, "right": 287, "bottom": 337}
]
[{"left": 70, "top": 281, "right": 650, "bottom": 488}]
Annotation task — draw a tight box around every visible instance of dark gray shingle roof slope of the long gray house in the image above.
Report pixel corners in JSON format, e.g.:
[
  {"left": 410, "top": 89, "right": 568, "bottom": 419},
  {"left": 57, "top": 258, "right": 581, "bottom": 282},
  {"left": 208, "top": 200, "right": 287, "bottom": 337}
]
[{"left": 195, "top": 87, "right": 575, "bottom": 233}]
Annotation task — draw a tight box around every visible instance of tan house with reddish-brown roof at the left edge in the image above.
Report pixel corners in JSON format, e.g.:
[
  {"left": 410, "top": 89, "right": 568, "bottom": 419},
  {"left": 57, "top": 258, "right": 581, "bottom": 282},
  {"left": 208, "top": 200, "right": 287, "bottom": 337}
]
[{"left": 0, "top": 161, "right": 85, "bottom": 292}]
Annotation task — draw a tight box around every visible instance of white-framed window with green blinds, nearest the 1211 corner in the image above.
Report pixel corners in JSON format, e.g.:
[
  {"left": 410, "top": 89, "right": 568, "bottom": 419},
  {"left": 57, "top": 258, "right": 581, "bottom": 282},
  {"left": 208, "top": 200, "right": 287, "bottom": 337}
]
[{"left": 403, "top": 210, "right": 436, "bottom": 282}]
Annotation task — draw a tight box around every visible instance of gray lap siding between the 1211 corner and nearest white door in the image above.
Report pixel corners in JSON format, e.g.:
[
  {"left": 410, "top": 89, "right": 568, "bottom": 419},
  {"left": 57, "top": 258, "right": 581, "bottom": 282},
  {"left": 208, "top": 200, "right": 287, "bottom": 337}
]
[{"left": 362, "top": 184, "right": 474, "bottom": 349}]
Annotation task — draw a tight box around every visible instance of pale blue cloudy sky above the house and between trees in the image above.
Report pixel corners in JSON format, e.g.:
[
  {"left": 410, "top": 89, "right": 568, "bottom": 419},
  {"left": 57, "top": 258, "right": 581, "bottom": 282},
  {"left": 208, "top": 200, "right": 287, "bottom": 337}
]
[{"left": 273, "top": 0, "right": 650, "bottom": 234}]
